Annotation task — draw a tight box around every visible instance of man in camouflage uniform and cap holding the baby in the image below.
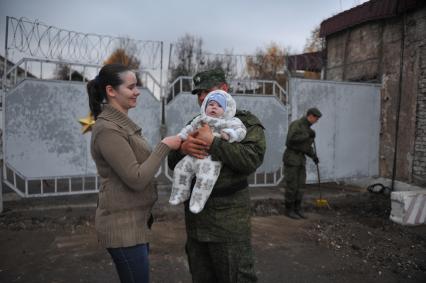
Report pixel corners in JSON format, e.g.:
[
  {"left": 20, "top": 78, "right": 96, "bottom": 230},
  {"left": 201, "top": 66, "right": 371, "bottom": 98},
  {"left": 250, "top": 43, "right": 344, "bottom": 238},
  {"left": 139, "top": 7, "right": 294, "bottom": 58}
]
[{"left": 168, "top": 69, "right": 266, "bottom": 283}]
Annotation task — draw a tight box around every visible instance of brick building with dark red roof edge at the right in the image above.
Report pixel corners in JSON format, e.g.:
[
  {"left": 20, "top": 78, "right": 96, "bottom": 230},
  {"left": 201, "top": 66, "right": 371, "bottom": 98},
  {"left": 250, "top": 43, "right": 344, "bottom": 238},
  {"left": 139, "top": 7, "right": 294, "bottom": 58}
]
[{"left": 320, "top": 0, "right": 426, "bottom": 186}]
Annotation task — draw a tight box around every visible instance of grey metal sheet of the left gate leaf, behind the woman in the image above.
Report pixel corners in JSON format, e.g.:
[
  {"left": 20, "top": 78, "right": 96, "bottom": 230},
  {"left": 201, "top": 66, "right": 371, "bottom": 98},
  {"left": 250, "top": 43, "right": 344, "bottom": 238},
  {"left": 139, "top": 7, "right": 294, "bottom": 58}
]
[{"left": 4, "top": 80, "right": 161, "bottom": 178}]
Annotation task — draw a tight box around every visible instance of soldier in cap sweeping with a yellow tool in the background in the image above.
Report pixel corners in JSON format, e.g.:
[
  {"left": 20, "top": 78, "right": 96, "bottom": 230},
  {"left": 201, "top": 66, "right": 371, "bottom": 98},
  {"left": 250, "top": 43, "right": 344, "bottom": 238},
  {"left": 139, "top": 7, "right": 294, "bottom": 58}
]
[{"left": 283, "top": 108, "right": 322, "bottom": 219}]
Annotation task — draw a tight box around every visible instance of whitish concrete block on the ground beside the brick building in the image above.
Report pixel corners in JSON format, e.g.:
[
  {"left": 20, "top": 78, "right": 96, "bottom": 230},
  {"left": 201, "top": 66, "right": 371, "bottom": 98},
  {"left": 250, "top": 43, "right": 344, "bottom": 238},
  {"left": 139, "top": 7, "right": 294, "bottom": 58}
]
[{"left": 390, "top": 190, "right": 426, "bottom": 225}]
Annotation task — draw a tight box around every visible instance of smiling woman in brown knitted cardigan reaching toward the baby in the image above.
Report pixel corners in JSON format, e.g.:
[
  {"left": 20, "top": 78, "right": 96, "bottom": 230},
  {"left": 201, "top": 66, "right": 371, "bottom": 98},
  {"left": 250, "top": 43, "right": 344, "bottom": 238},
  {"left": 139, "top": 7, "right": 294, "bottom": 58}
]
[{"left": 87, "top": 64, "right": 181, "bottom": 282}]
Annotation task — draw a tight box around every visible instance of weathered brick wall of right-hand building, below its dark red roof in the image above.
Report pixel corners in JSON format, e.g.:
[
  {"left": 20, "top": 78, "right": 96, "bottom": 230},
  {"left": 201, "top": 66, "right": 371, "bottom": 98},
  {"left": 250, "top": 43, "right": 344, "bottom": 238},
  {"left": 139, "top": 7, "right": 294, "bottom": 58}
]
[{"left": 326, "top": 7, "right": 426, "bottom": 185}]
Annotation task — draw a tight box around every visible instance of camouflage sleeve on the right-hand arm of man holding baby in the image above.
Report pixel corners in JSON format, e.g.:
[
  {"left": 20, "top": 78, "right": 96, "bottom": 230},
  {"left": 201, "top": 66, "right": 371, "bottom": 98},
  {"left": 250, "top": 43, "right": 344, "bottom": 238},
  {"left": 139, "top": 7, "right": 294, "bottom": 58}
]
[{"left": 209, "top": 111, "right": 266, "bottom": 174}]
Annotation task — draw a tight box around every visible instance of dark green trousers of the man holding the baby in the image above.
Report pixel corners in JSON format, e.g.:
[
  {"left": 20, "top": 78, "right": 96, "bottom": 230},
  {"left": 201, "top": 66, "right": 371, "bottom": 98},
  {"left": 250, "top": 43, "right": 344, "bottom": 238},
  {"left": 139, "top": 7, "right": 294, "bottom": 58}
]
[{"left": 185, "top": 237, "right": 257, "bottom": 283}]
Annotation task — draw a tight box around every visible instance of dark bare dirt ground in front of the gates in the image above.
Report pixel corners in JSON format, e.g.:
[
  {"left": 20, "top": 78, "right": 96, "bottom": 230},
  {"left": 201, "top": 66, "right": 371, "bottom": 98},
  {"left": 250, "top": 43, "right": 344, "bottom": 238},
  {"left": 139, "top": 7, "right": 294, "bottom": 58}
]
[{"left": 0, "top": 184, "right": 426, "bottom": 283}]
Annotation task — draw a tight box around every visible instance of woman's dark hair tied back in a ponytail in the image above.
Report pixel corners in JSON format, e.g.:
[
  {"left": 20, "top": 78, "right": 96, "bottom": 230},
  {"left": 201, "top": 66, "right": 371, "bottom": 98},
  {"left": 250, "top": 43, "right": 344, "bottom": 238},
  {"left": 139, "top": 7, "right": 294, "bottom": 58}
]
[{"left": 86, "top": 64, "right": 131, "bottom": 120}]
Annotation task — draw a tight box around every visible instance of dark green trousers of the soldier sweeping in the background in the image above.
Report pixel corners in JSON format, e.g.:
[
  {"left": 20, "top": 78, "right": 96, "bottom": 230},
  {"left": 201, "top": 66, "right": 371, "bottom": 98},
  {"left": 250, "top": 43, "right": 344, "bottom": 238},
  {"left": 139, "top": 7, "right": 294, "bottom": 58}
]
[{"left": 284, "top": 165, "right": 306, "bottom": 208}]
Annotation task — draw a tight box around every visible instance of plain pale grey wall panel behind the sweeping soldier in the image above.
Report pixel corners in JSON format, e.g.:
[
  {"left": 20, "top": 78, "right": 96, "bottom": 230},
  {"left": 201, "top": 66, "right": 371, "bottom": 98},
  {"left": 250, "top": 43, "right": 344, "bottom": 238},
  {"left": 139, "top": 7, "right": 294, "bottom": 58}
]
[{"left": 290, "top": 79, "right": 380, "bottom": 181}]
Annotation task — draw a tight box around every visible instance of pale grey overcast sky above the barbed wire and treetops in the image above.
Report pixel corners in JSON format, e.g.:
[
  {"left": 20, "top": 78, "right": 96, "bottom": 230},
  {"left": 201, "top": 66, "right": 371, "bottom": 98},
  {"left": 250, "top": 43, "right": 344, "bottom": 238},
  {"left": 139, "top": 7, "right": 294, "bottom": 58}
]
[{"left": 0, "top": 0, "right": 365, "bottom": 54}]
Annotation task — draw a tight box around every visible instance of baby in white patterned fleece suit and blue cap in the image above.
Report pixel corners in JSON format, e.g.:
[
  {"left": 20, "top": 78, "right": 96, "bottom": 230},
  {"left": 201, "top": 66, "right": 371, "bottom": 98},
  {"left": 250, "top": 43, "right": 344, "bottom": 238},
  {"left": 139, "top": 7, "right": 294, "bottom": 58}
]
[{"left": 169, "top": 90, "right": 247, "bottom": 213}]
